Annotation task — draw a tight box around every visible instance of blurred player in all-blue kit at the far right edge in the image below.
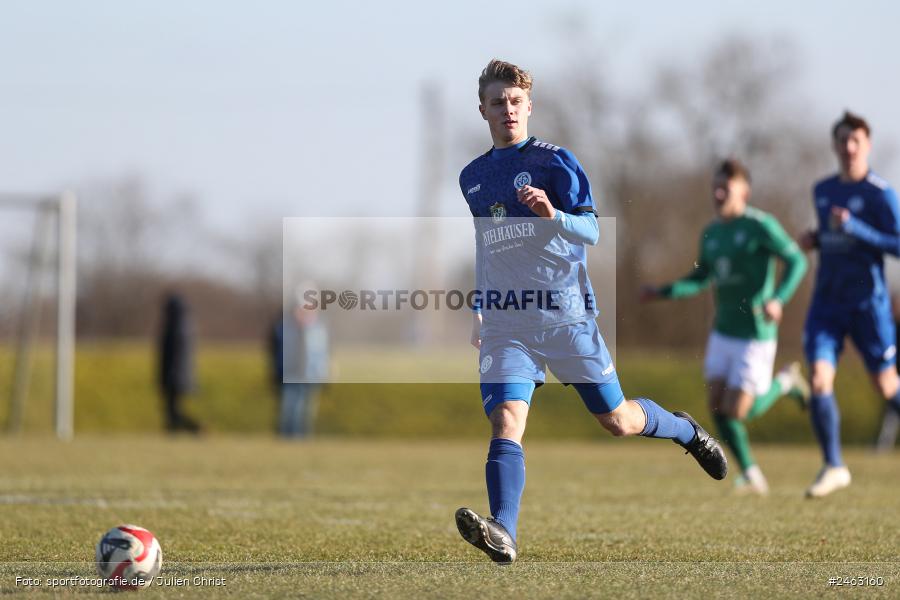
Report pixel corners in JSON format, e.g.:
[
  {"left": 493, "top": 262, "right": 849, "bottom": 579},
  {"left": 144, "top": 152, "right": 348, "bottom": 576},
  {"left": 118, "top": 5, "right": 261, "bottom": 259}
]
[{"left": 800, "top": 112, "right": 900, "bottom": 498}]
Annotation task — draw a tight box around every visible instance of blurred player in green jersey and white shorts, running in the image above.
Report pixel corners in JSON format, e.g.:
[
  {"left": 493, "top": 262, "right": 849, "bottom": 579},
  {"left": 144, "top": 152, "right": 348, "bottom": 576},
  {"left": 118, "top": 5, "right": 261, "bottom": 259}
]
[{"left": 642, "top": 159, "right": 809, "bottom": 494}]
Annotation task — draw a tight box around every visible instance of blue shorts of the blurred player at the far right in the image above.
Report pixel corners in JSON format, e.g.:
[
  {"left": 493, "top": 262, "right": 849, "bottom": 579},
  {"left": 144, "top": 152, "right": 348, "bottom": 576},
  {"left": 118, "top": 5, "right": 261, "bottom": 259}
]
[{"left": 803, "top": 296, "right": 897, "bottom": 373}]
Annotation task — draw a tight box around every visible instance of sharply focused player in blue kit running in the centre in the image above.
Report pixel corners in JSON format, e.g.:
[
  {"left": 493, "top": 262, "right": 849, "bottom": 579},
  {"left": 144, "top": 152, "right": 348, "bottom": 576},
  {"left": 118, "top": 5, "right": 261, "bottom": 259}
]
[{"left": 456, "top": 60, "right": 727, "bottom": 563}]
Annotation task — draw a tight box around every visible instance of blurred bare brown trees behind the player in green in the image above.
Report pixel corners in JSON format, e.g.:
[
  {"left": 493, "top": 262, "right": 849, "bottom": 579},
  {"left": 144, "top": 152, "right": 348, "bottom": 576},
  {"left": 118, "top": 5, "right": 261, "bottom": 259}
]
[{"left": 500, "top": 38, "right": 892, "bottom": 349}]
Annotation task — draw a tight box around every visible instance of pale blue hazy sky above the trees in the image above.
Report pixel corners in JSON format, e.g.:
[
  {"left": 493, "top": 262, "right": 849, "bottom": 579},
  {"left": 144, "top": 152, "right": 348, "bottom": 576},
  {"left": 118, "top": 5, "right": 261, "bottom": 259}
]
[{"left": 0, "top": 0, "right": 900, "bottom": 232}]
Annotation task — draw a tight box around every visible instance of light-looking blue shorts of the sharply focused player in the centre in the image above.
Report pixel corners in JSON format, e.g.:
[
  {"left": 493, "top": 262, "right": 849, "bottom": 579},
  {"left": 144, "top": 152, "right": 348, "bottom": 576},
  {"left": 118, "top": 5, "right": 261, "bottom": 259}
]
[{"left": 479, "top": 320, "right": 625, "bottom": 415}]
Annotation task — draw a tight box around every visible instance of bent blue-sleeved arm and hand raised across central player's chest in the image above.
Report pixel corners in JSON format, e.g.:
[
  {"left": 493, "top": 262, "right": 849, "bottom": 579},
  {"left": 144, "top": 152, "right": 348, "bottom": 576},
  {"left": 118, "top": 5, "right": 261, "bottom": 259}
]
[{"left": 517, "top": 148, "right": 600, "bottom": 246}]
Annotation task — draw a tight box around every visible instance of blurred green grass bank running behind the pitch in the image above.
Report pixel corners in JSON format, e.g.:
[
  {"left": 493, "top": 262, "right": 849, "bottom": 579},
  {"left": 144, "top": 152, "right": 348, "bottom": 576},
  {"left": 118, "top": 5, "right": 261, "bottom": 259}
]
[{"left": 0, "top": 342, "right": 882, "bottom": 444}]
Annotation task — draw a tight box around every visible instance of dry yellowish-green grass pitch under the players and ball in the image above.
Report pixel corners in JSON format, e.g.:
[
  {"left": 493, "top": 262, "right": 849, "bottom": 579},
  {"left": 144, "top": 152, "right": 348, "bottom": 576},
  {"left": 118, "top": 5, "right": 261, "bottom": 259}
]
[{"left": 0, "top": 435, "right": 900, "bottom": 599}]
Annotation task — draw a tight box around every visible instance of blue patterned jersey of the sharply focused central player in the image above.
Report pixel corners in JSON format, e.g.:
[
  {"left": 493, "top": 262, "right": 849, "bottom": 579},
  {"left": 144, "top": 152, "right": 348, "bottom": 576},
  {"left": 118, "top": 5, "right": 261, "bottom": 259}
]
[{"left": 459, "top": 138, "right": 598, "bottom": 334}]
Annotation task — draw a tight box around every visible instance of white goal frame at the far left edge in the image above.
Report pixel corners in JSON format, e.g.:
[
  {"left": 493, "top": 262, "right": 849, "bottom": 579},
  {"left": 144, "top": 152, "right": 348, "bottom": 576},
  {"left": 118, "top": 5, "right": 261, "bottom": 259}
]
[{"left": 0, "top": 191, "right": 78, "bottom": 440}]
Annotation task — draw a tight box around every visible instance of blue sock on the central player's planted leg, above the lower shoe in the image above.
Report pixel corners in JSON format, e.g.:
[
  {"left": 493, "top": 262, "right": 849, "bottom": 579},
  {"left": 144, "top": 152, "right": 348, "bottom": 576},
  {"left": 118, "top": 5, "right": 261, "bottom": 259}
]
[{"left": 484, "top": 438, "right": 525, "bottom": 540}]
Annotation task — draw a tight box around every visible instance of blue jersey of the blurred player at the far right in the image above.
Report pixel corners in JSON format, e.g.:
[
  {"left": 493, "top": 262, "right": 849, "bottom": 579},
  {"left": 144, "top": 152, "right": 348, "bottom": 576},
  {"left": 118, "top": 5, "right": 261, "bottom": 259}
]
[{"left": 813, "top": 172, "right": 900, "bottom": 310}]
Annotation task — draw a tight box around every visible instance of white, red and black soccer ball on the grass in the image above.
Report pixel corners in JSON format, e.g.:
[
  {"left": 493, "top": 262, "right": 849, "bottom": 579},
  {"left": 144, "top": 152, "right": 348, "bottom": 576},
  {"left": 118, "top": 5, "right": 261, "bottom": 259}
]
[{"left": 97, "top": 525, "right": 162, "bottom": 589}]
